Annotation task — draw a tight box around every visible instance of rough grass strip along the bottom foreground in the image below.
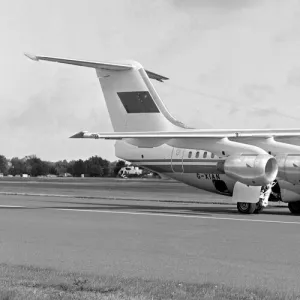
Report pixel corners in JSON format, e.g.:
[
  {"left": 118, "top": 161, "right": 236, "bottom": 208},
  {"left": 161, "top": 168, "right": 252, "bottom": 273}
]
[{"left": 0, "top": 264, "right": 300, "bottom": 300}]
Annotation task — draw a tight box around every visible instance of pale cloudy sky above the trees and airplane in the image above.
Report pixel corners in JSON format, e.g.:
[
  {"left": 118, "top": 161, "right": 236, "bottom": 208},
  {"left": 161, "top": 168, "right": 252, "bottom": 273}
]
[{"left": 0, "top": 0, "right": 300, "bottom": 161}]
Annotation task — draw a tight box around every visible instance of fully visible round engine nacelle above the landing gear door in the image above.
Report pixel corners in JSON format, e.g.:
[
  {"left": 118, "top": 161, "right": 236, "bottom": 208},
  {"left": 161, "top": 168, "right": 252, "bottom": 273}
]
[{"left": 218, "top": 154, "right": 278, "bottom": 186}]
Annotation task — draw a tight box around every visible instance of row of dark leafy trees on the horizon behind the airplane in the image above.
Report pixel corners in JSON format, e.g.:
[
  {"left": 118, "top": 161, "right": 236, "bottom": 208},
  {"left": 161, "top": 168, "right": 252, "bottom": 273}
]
[{"left": 0, "top": 155, "right": 132, "bottom": 177}]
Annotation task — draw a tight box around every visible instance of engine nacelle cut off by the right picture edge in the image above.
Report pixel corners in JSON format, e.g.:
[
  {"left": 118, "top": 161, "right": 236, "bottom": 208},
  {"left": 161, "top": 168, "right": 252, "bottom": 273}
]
[{"left": 276, "top": 154, "right": 300, "bottom": 184}]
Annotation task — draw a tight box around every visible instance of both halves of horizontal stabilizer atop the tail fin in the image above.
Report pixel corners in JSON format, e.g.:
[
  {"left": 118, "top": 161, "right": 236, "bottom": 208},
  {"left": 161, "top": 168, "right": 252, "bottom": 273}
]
[{"left": 24, "top": 53, "right": 169, "bottom": 82}]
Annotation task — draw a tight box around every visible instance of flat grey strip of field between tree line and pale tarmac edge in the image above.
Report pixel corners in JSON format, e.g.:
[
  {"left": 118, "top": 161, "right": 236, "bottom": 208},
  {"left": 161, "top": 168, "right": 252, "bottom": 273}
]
[{"left": 0, "top": 178, "right": 220, "bottom": 202}]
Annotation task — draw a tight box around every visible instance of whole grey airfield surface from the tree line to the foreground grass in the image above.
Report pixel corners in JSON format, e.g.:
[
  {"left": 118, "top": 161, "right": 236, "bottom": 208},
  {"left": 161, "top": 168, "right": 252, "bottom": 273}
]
[{"left": 0, "top": 179, "right": 300, "bottom": 291}]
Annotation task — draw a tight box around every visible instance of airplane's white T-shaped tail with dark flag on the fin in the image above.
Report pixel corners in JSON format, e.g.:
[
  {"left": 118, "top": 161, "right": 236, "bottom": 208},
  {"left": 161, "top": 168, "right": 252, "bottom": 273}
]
[{"left": 26, "top": 54, "right": 188, "bottom": 132}]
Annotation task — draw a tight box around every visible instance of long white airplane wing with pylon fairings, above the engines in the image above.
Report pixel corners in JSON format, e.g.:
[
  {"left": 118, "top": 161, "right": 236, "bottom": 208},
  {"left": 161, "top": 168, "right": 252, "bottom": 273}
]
[{"left": 70, "top": 129, "right": 300, "bottom": 155}]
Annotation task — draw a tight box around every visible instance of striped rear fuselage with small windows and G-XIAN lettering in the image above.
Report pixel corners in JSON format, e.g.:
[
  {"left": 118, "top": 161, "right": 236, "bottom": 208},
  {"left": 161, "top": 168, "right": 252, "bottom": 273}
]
[{"left": 115, "top": 141, "right": 236, "bottom": 196}]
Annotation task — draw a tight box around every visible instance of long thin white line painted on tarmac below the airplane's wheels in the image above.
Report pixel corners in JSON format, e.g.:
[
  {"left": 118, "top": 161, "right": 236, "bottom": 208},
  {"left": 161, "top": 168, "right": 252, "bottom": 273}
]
[{"left": 55, "top": 208, "right": 300, "bottom": 225}]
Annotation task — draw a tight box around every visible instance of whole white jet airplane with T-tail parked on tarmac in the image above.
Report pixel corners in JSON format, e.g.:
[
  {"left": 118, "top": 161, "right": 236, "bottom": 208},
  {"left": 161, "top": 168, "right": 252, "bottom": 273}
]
[{"left": 25, "top": 53, "right": 300, "bottom": 214}]
